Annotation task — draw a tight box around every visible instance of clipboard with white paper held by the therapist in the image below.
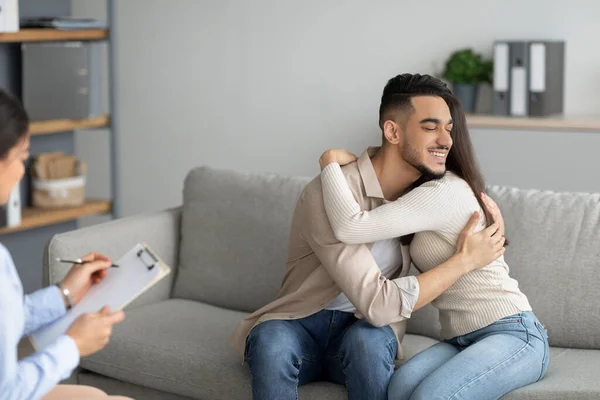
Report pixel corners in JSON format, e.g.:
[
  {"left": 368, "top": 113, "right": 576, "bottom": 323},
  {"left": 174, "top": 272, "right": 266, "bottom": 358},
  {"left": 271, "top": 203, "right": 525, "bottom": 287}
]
[{"left": 29, "top": 243, "right": 171, "bottom": 351}]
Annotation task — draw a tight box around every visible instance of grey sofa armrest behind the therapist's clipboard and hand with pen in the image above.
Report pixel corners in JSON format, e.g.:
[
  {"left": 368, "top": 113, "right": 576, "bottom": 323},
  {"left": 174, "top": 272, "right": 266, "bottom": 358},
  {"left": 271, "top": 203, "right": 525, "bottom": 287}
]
[{"left": 43, "top": 207, "right": 181, "bottom": 308}]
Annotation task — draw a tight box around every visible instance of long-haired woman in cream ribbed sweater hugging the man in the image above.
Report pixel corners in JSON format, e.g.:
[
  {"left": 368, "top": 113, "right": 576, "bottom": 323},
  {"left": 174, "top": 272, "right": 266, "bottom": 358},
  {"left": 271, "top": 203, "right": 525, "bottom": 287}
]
[{"left": 321, "top": 87, "right": 549, "bottom": 400}]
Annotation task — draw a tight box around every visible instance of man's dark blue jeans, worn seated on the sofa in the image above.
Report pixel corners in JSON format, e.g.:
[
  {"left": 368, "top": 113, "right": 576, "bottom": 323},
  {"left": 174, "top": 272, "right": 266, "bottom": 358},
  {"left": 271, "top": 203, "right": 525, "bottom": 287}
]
[{"left": 246, "top": 310, "right": 398, "bottom": 400}]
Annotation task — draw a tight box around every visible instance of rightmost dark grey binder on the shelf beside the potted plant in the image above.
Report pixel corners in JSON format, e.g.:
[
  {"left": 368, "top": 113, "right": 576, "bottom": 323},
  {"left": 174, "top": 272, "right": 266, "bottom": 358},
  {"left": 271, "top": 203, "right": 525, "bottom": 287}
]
[{"left": 528, "top": 41, "right": 565, "bottom": 117}]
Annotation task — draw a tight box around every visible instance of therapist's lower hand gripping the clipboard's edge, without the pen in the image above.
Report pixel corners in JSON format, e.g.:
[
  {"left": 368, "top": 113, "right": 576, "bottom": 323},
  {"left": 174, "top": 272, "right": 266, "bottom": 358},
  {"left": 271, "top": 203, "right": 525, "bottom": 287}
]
[{"left": 67, "top": 307, "right": 125, "bottom": 357}]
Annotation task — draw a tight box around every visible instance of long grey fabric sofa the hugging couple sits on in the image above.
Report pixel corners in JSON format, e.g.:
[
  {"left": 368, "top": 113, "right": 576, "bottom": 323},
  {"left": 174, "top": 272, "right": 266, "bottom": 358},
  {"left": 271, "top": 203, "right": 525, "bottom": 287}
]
[{"left": 45, "top": 167, "right": 600, "bottom": 400}]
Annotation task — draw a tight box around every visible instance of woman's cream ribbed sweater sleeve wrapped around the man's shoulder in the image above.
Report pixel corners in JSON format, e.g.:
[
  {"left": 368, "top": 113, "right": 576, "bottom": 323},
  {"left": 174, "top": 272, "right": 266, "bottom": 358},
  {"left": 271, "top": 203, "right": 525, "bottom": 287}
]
[{"left": 321, "top": 163, "right": 455, "bottom": 244}]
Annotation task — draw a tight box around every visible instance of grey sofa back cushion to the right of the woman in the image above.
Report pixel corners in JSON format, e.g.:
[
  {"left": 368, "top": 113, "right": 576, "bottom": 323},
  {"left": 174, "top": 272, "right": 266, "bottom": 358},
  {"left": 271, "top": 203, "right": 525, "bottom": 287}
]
[{"left": 489, "top": 186, "right": 600, "bottom": 349}]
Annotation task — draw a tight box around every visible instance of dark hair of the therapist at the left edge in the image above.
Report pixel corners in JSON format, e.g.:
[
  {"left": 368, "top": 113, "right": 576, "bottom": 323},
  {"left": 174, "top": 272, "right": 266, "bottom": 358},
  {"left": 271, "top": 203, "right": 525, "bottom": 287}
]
[{"left": 0, "top": 89, "right": 29, "bottom": 159}]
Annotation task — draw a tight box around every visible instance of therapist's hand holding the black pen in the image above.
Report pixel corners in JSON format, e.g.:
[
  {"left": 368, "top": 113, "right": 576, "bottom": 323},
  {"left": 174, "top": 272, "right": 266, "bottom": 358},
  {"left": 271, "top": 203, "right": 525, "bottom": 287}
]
[{"left": 62, "top": 253, "right": 111, "bottom": 304}]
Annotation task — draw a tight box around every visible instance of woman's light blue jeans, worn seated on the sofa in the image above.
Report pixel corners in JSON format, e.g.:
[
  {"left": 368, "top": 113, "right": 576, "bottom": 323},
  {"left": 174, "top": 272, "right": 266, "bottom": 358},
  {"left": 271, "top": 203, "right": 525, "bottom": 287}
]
[{"left": 389, "top": 312, "right": 550, "bottom": 400}]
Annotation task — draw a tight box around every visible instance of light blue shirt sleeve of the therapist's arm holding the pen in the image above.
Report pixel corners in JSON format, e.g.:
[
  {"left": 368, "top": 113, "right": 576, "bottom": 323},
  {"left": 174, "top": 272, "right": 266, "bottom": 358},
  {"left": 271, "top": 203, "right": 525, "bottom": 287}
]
[{"left": 23, "top": 285, "right": 66, "bottom": 335}]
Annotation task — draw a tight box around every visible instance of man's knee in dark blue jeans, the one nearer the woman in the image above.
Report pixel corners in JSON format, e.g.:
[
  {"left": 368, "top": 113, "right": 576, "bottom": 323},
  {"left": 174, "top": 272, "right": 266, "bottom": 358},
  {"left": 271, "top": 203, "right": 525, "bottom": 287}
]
[{"left": 342, "top": 320, "right": 398, "bottom": 362}]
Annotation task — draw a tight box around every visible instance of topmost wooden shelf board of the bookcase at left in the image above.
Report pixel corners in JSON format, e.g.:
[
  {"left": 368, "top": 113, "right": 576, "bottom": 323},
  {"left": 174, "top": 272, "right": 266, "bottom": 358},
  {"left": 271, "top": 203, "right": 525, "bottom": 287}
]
[{"left": 0, "top": 28, "right": 108, "bottom": 43}]
